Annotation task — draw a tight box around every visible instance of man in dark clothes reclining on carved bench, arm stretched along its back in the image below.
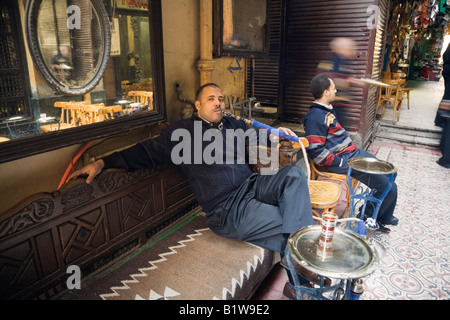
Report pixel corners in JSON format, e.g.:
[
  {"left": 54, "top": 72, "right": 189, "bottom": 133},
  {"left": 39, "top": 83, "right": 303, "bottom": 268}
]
[{"left": 69, "top": 83, "right": 313, "bottom": 297}]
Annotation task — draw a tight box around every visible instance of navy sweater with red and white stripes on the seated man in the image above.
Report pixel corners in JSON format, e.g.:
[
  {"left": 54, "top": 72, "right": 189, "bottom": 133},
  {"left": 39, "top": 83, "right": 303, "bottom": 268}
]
[{"left": 302, "top": 102, "right": 356, "bottom": 168}]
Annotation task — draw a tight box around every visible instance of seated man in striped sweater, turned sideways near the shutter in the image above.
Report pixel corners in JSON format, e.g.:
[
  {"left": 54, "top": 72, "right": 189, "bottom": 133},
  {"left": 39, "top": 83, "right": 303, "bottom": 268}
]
[{"left": 302, "top": 74, "right": 398, "bottom": 232}]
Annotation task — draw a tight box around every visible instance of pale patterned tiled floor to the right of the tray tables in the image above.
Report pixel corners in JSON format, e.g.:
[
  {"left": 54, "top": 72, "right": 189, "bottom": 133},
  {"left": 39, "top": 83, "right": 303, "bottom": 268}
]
[{"left": 362, "top": 145, "right": 450, "bottom": 300}]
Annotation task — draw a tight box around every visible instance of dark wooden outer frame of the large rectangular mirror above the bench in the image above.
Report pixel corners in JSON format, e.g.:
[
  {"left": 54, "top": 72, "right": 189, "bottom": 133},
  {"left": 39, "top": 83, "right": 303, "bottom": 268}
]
[{"left": 0, "top": 0, "right": 166, "bottom": 163}]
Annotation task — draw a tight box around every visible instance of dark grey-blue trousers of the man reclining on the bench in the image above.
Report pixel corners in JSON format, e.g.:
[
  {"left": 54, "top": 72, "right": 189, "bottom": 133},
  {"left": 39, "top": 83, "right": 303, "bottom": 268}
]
[{"left": 206, "top": 166, "right": 313, "bottom": 252}]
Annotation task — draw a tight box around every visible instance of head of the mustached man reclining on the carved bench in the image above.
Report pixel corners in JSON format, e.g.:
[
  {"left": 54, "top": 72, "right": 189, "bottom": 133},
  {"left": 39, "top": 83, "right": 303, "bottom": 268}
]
[{"left": 195, "top": 86, "right": 225, "bottom": 123}]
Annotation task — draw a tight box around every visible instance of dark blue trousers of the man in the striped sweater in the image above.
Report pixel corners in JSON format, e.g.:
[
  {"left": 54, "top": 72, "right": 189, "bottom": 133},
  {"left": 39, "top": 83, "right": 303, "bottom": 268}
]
[{"left": 327, "top": 149, "right": 397, "bottom": 223}]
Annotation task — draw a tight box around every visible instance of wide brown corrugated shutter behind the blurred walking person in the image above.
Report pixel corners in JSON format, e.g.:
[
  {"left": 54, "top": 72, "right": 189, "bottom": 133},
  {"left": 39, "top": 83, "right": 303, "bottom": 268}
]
[{"left": 279, "top": 0, "right": 388, "bottom": 146}]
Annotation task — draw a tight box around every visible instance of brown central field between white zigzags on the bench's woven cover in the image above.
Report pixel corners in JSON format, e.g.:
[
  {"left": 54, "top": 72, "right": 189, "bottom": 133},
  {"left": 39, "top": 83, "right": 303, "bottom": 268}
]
[{"left": 100, "top": 228, "right": 264, "bottom": 300}]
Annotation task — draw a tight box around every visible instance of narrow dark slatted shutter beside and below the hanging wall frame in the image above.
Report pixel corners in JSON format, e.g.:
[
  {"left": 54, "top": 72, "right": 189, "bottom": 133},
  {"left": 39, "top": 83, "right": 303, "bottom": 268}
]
[{"left": 246, "top": 0, "right": 282, "bottom": 106}]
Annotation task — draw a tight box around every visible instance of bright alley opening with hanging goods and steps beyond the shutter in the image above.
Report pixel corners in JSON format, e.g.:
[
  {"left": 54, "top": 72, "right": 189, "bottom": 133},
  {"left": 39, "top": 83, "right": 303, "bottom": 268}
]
[{"left": 377, "top": 0, "right": 444, "bottom": 142}]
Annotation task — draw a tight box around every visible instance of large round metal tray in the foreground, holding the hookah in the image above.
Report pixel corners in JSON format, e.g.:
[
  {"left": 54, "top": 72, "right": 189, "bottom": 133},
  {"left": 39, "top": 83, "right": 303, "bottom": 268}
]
[{"left": 287, "top": 225, "right": 379, "bottom": 279}]
